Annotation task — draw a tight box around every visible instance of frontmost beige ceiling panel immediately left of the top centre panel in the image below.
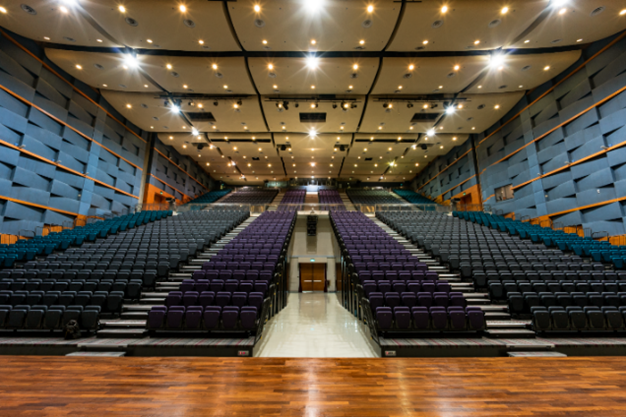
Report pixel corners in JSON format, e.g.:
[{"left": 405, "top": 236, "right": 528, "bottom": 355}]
[{"left": 81, "top": 0, "right": 240, "bottom": 51}]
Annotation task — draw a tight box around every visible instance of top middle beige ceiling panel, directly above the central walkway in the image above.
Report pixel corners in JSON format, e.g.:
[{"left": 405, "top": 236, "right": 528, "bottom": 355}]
[{"left": 228, "top": 0, "right": 401, "bottom": 51}]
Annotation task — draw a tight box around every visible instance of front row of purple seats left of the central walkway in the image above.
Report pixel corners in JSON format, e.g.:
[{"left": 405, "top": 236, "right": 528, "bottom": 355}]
[{"left": 146, "top": 306, "right": 258, "bottom": 331}]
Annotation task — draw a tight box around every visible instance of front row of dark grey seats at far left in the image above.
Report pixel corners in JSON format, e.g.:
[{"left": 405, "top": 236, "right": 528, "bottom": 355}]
[{"left": 0, "top": 305, "right": 100, "bottom": 330}]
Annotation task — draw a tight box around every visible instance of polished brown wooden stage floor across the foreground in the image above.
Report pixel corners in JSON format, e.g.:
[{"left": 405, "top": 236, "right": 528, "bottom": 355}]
[{"left": 0, "top": 356, "right": 626, "bottom": 417}]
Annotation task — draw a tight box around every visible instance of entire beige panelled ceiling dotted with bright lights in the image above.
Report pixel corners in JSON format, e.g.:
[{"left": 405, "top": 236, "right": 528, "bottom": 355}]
[{"left": 0, "top": 0, "right": 626, "bottom": 184}]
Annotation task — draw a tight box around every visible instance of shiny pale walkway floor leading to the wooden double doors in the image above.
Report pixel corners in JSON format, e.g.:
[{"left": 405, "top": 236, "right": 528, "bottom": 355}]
[{"left": 254, "top": 292, "right": 378, "bottom": 358}]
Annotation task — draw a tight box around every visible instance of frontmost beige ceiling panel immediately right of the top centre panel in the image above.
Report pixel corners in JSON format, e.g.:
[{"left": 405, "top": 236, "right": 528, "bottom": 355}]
[{"left": 389, "top": 0, "right": 548, "bottom": 51}]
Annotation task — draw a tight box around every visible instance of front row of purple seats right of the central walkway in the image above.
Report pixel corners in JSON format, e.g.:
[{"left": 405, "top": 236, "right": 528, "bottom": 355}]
[{"left": 375, "top": 306, "right": 485, "bottom": 332}]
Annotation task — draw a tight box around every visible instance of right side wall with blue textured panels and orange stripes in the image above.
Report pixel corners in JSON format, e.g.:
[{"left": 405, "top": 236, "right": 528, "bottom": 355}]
[{"left": 413, "top": 32, "right": 626, "bottom": 235}]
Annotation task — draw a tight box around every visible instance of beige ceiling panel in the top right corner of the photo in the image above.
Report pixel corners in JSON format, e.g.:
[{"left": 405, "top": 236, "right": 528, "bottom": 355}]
[{"left": 513, "top": 0, "right": 626, "bottom": 48}]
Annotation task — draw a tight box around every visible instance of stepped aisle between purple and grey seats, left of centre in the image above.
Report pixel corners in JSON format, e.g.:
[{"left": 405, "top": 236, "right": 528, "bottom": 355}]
[{"left": 96, "top": 216, "right": 256, "bottom": 339}]
